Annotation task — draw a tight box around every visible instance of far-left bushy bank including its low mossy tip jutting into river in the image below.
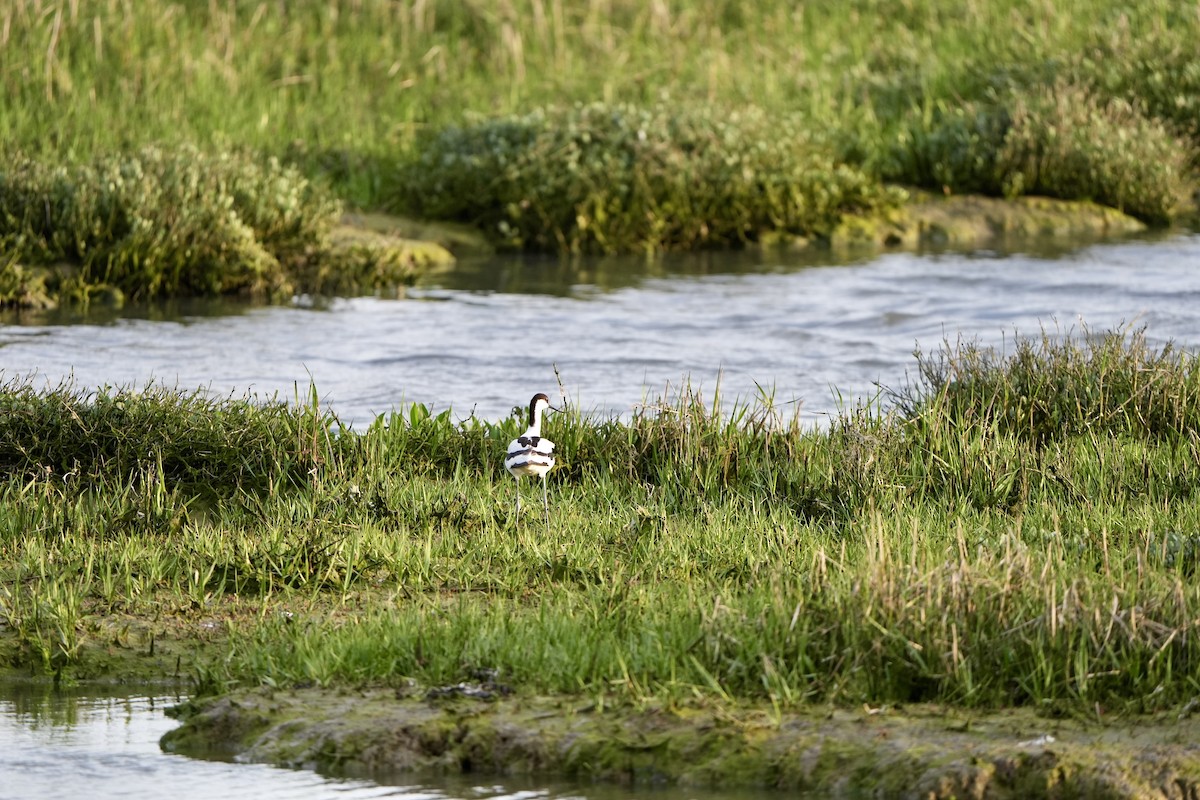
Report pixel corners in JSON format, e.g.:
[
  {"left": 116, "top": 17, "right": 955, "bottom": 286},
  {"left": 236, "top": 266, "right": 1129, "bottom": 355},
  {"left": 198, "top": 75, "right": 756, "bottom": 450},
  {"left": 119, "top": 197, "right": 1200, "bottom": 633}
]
[{"left": 0, "top": 146, "right": 451, "bottom": 308}]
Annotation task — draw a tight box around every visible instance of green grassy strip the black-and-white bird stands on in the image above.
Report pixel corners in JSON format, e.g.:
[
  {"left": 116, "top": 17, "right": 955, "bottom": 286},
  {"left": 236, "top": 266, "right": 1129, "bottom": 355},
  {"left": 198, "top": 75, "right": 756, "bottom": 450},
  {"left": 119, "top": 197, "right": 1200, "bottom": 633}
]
[{"left": 0, "top": 332, "right": 1200, "bottom": 711}]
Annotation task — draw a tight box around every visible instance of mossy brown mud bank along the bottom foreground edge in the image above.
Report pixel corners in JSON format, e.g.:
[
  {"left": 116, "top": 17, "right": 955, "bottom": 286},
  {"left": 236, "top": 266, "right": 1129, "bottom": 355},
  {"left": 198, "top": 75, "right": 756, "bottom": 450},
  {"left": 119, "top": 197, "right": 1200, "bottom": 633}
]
[{"left": 162, "top": 685, "right": 1200, "bottom": 798}]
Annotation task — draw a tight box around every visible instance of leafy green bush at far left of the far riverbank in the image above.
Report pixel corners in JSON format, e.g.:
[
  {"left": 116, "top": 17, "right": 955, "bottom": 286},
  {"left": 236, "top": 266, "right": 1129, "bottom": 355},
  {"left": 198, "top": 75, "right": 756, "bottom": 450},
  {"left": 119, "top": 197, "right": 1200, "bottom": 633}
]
[{"left": 0, "top": 148, "right": 341, "bottom": 299}]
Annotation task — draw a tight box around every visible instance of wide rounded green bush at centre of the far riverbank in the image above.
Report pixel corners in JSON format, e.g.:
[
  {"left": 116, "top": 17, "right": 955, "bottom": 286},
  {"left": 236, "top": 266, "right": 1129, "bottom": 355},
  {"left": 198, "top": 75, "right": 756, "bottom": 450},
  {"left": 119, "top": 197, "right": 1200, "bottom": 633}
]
[{"left": 397, "top": 104, "right": 902, "bottom": 252}]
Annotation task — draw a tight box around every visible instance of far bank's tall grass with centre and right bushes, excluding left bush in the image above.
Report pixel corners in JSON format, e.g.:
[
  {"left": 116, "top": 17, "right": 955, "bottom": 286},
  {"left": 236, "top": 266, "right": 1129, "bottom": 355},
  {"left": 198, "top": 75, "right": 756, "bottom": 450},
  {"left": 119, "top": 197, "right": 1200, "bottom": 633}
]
[{"left": 0, "top": 0, "right": 1200, "bottom": 262}]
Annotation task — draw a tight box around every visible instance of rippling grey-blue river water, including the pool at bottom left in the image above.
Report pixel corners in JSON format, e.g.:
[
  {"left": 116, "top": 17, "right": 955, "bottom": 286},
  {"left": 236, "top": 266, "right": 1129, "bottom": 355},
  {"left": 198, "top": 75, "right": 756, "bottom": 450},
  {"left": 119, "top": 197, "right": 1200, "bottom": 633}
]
[{"left": 0, "top": 235, "right": 1200, "bottom": 800}]
